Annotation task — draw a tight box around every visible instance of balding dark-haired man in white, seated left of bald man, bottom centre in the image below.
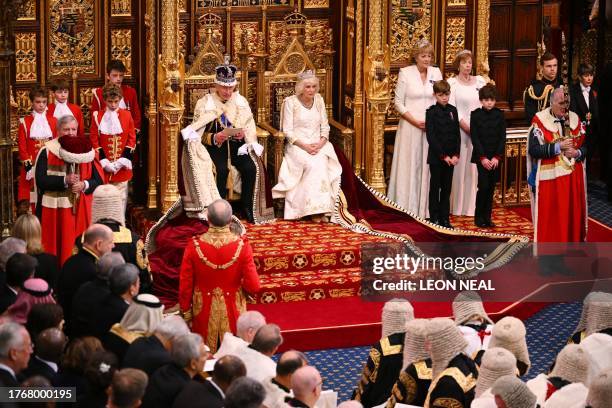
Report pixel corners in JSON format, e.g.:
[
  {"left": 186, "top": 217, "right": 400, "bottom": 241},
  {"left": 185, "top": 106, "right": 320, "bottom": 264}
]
[{"left": 262, "top": 350, "right": 308, "bottom": 408}]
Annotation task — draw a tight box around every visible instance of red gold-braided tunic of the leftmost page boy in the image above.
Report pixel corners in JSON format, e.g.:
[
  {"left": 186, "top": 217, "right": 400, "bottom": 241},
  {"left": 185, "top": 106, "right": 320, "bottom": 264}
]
[{"left": 17, "top": 111, "right": 57, "bottom": 204}]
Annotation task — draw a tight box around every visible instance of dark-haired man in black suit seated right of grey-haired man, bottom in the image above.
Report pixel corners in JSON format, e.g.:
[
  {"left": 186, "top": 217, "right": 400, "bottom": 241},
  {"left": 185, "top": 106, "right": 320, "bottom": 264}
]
[{"left": 172, "top": 355, "right": 246, "bottom": 408}]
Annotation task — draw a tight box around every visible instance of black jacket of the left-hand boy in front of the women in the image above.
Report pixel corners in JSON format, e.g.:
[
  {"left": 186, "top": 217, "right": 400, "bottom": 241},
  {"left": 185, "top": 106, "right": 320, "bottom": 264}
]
[{"left": 425, "top": 103, "right": 461, "bottom": 165}]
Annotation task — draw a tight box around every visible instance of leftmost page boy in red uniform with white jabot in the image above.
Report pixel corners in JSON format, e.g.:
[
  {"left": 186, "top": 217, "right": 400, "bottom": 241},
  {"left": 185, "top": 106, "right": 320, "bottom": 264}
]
[{"left": 17, "top": 85, "right": 57, "bottom": 213}]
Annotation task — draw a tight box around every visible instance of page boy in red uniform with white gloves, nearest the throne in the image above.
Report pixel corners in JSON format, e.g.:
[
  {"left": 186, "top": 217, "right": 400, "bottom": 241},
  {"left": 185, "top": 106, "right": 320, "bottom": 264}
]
[{"left": 89, "top": 84, "right": 136, "bottom": 212}]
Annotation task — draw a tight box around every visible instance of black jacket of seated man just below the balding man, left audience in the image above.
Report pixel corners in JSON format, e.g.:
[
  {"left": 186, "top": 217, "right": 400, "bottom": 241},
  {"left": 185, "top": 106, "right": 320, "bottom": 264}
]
[{"left": 70, "top": 277, "right": 110, "bottom": 337}]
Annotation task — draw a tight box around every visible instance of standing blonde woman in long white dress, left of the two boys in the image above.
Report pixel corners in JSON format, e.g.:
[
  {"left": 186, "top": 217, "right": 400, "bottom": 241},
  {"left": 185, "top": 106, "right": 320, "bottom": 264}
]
[{"left": 388, "top": 40, "right": 442, "bottom": 218}]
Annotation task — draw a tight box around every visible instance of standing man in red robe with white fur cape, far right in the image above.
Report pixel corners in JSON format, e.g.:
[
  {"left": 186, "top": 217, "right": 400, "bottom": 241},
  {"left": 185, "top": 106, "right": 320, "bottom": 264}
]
[{"left": 528, "top": 88, "right": 587, "bottom": 242}]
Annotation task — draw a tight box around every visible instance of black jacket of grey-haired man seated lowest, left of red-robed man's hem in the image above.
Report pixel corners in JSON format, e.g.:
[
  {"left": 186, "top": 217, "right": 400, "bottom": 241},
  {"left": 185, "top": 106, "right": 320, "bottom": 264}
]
[{"left": 142, "top": 363, "right": 191, "bottom": 408}]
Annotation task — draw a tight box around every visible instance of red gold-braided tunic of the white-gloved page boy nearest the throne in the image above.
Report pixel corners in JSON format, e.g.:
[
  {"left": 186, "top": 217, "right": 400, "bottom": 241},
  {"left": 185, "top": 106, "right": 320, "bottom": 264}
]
[{"left": 89, "top": 109, "right": 136, "bottom": 183}]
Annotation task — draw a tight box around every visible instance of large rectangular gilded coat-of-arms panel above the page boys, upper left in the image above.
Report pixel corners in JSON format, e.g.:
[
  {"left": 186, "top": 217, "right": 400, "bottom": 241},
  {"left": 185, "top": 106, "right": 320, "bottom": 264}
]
[{"left": 47, "top": 0, "right": 99, "bottom": 76}]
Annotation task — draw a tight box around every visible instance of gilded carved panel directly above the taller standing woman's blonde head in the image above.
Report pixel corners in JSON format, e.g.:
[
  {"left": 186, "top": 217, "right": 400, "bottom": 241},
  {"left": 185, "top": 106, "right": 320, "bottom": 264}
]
[{"left": 389, "top": 0, "right": 436, "bottom": 62}]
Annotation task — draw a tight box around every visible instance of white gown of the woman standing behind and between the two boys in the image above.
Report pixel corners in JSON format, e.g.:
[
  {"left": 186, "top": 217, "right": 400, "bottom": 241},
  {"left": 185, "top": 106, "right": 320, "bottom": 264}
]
[{"left": 448, "top": 76, "right": 487, "bottom": 217}]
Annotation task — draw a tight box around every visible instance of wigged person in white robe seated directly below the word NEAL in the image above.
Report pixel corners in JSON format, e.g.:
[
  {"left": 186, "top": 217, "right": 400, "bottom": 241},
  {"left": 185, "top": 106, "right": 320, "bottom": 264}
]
[{"left": 453, "top": 291, "right": 493, "bottom": 359}]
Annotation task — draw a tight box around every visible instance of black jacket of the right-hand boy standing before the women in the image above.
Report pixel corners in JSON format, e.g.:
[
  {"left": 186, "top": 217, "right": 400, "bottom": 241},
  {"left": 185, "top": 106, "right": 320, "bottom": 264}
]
[{"left": 470, "top": 108, "right": 506, "bottom": 163}]
